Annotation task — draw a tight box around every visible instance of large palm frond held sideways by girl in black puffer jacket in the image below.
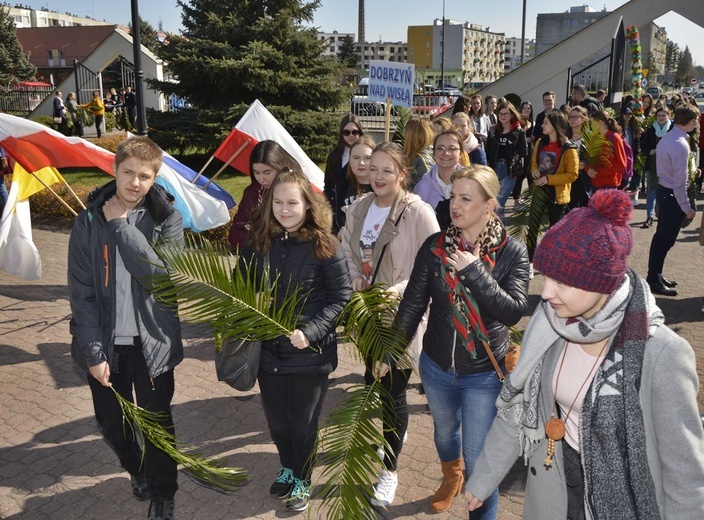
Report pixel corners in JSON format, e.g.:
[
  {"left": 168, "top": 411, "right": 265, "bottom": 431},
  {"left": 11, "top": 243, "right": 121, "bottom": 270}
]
[{"left": 152, "top": 236, "right": 304, "bottom": 341}]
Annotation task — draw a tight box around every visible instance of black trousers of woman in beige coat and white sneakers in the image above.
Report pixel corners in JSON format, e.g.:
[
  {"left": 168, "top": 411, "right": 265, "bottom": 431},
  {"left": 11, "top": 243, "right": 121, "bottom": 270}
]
[{"left": 364, "top": 368, "right": 413, "bottom": 471}]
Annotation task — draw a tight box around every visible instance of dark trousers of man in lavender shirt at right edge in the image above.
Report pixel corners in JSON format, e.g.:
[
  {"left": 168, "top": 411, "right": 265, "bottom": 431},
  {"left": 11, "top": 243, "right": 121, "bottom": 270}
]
[{"left": 646, "top": 185, "right": 686, "bottom": 283}]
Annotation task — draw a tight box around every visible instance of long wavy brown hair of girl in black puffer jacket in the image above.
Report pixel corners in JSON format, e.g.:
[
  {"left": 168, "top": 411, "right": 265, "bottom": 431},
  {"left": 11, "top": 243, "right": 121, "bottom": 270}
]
[{"left": 248, "top": 168, "right": 337, "bottom": 260}]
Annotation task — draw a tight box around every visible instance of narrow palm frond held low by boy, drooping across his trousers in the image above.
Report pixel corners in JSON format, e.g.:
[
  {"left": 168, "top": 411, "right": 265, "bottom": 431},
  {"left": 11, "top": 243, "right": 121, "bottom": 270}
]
[{"left": 110, "top": 387, "right": 249, "bottom": 493}]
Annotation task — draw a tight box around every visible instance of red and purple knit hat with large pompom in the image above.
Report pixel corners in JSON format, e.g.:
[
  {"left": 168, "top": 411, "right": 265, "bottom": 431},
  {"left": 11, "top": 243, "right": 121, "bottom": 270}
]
[{"left": 533, "top": 190, "right": 633, "bottom": 294}]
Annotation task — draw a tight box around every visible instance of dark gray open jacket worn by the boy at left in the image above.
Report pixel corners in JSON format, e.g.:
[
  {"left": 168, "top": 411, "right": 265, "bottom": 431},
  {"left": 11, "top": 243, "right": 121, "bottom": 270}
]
[{"left": 68, "top": 181, "right": 183, "bottom": 378}]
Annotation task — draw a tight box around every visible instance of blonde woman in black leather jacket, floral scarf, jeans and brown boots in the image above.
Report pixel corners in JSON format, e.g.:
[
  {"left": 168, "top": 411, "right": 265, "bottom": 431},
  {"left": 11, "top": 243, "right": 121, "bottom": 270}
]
[{"left": 395, "top": 165, "right": 529, "bottom": 520}]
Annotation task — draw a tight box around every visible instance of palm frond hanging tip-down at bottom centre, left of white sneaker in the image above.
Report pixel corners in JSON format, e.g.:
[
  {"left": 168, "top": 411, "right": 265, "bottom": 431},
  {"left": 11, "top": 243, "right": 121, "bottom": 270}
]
[{"left": 316, "top": 381, "right": 395, "bottom": 520}]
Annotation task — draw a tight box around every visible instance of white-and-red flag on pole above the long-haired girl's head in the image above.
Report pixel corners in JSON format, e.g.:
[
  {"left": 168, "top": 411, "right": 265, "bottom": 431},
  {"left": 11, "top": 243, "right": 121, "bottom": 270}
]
[{"left": 213, "top": 99, "right": 325, "bottom": 191}]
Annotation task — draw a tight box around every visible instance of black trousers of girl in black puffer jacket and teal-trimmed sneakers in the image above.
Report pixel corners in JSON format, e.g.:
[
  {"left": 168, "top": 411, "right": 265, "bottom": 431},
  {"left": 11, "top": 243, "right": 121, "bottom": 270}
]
[{"left": 258, "top": 370, "right": 329, "bottom": 480}]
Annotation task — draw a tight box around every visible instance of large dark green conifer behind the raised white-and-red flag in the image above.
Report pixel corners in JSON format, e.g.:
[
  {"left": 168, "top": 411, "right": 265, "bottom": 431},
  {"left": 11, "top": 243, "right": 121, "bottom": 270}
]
[{"left": 152, "top": 0, "right": 342, "bottom": 110}]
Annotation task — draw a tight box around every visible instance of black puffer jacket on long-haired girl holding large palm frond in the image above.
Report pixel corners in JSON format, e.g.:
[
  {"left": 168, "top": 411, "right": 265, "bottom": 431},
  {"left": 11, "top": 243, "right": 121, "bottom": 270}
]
[{"left": 240, "top": 233, "right": 352, "bottom": 375}]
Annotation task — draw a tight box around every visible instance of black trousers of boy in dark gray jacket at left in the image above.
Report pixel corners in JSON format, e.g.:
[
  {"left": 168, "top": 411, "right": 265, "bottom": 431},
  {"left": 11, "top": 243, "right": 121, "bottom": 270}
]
[{"left": 88, "top": 345, "right": 178, "bottom": 498}]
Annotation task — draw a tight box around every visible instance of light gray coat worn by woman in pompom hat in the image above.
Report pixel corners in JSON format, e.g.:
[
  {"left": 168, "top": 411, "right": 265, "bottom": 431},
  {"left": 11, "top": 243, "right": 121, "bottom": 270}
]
[{"left": 465, "top": 325, "right": 704, "bottom": 520}]
